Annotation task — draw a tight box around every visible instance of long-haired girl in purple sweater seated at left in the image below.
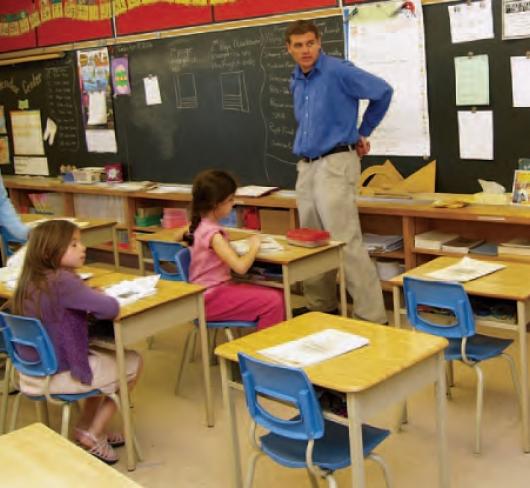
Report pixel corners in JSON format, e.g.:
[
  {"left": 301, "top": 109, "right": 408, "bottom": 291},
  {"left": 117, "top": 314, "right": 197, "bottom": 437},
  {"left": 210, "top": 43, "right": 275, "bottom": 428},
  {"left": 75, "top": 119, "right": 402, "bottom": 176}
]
[{"left": 13, "top": 220, "right": 141, "bottom": 463}]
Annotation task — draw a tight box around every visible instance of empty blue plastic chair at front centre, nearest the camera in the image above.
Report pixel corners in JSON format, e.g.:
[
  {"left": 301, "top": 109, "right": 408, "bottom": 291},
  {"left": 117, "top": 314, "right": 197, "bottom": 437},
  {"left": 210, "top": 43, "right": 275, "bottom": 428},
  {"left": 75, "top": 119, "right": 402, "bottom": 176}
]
[{"left": 238, "top": 353, "right": 390, "bottom": 488}]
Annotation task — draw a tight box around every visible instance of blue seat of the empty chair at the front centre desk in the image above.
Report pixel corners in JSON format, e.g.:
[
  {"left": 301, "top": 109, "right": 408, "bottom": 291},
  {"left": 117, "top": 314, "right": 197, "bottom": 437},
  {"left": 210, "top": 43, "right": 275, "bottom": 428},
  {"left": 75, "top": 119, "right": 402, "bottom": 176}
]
[{"left": 261, "top": 420, "right": 390, "bottom": 471}]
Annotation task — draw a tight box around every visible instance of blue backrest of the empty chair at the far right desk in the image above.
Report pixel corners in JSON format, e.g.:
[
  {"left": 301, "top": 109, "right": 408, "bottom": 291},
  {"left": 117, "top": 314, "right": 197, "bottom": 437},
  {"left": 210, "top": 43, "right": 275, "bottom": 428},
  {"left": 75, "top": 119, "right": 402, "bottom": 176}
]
[{"left": 403, "top": 276, "right": 475, "bottom": 339}]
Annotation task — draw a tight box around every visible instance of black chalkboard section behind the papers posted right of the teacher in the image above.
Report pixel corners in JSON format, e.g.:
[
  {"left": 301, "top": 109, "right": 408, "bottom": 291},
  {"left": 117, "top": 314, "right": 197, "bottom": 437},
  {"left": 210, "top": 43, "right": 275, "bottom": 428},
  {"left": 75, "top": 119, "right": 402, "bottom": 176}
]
[{"left": 363, "top": 0, "right": 530, "bottom": 193}]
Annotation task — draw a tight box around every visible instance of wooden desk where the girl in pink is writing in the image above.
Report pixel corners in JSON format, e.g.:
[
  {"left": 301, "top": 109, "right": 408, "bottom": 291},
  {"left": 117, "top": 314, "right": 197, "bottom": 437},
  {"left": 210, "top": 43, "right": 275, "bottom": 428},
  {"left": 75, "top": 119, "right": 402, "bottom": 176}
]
[{"left": 137, "top": 229, "right": 347, "bottom": 319}]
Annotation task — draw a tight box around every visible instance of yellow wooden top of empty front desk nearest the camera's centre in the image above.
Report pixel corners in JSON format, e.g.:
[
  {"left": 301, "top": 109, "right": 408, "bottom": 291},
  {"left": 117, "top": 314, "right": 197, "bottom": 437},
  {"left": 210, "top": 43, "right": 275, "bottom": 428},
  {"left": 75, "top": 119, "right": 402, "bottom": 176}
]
[{"left": 215, "top": 312, "right": 447, "bottom": 393}]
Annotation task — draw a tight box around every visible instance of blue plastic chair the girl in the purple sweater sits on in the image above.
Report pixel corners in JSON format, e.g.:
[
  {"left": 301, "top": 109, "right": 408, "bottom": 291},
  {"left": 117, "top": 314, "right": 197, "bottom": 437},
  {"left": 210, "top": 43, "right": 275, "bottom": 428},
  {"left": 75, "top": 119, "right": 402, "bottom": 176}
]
[{"left": 0, "top": 312, "right": 141, "bottom": 458}]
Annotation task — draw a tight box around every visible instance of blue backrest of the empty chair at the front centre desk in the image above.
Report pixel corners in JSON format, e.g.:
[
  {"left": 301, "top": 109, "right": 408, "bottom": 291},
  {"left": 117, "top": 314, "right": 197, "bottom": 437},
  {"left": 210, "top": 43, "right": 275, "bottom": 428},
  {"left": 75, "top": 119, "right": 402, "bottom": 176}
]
[{"left": 238, "top": 353, "right": 324, "bottom": 440}]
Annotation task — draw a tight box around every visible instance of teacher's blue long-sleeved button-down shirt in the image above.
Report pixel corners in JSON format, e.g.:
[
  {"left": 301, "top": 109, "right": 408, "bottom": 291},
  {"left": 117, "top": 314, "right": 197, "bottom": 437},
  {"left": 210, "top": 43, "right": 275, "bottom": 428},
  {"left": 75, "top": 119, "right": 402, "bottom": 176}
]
[{"left": 290, "top": 53, "right": 393, "bottom": 158}]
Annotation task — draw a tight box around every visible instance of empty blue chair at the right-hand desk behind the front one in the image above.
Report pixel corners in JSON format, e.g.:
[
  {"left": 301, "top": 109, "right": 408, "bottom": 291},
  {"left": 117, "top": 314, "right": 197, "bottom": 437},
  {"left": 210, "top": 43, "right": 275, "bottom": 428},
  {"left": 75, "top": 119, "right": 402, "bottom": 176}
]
[{"left": 403, "top": 276, "right": 521, "bottom": 454}]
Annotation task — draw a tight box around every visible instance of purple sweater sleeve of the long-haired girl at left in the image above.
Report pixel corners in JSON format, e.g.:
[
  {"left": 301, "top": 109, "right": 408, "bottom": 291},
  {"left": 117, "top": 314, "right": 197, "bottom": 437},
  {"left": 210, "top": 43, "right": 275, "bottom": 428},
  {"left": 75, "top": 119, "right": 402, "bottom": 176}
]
[{"left": 58, "top": 271, "right": 120, "bottom": 320}]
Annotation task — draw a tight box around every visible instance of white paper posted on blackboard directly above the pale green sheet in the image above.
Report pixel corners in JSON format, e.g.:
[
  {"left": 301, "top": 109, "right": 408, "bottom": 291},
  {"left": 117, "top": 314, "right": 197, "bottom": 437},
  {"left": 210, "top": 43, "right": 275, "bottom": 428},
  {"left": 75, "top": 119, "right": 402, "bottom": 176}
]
[{"left": 447, "top": 0, "right": 494, "bottom": 44}]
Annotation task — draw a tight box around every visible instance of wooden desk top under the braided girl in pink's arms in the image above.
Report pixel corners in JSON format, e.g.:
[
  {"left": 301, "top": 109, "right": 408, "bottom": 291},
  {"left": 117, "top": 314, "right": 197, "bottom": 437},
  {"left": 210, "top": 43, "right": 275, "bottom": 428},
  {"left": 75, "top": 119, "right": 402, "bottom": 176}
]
[{"left": 136, "top": 228, "right": 344, "bottom": 264}]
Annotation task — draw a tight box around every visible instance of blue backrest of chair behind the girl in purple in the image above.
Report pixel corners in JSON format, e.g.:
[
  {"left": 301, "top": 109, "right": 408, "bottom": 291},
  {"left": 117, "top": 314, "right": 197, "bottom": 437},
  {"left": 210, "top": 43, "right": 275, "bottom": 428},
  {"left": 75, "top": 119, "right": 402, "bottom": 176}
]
[{"left": 0, "top": 312, "right": 57, "bottom": 376}]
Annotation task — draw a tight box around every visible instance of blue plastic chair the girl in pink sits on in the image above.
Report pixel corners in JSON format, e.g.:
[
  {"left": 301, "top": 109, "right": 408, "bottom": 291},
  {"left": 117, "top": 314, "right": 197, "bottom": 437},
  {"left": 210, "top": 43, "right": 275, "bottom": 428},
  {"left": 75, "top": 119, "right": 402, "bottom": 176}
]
[{"left": 175, "top": 247, "right": 258, "bottom": 395}]
